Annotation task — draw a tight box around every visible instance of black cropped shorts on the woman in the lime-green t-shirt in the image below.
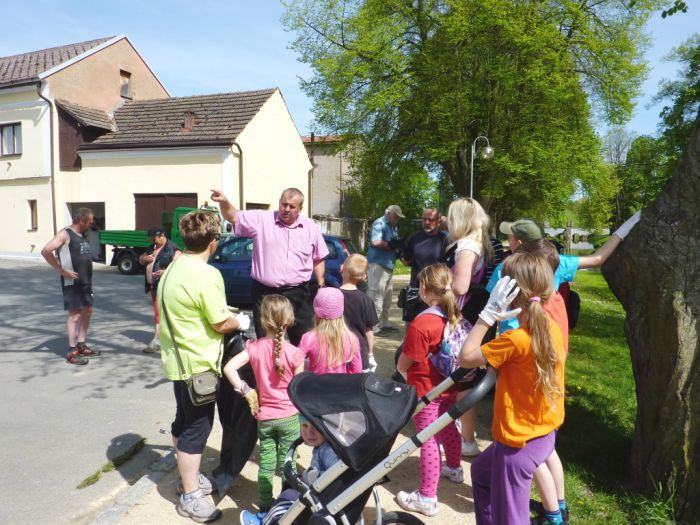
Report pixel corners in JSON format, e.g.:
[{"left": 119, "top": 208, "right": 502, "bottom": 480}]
[{"left": 170, "top": 381, "right": 216, "bottom": 454}]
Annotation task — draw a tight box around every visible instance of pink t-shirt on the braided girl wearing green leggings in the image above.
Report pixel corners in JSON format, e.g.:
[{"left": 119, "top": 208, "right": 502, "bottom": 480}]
[{"left": 246, "top": 337, "right": 304, "bottom": 421}]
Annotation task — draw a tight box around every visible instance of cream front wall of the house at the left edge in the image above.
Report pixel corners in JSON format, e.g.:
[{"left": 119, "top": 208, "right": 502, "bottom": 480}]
[{"left": 0, "top": 86, "right": 53, "bottom": 253}]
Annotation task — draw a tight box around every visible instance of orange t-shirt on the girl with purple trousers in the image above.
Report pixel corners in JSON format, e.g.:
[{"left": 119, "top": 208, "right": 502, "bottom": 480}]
[{"left": 481, "top": 322, "right": 564, "bottom": 448}]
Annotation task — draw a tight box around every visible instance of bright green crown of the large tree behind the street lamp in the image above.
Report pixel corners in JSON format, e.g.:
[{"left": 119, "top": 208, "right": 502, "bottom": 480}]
[{"left": 285, "top": 0, "right": 658, "bottom": 223}]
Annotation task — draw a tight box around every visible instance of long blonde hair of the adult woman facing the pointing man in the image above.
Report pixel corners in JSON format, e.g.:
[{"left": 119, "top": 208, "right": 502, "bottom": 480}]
[{"left": 447, "top": 197, "right": 494, "bottom": 264}]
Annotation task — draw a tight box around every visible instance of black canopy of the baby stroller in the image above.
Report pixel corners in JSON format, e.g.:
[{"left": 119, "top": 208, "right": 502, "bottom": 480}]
[{"left": 288, "top": 372, "right": 418, "bottom": 470}]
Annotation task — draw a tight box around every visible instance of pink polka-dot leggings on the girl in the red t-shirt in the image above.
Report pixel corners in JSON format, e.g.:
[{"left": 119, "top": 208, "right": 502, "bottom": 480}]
[{"left": 413, "top": 393, "right": 462, "bottom": 498}]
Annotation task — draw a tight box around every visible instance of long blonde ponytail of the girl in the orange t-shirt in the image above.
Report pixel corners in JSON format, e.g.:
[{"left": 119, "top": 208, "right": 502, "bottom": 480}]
[{"left": 502, "top": 252, "right": 564, "bottom": 408}]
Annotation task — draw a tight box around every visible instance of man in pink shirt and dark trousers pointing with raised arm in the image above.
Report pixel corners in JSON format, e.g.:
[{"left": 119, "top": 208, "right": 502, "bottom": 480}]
[{"left": 211, "top": 188, "right": 328, "bottom": 345}]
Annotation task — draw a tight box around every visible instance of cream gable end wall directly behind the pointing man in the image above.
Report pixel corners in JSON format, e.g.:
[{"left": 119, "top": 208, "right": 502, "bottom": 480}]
[{"left": 237, "top": 90, "right": 311, "bottom": 215}]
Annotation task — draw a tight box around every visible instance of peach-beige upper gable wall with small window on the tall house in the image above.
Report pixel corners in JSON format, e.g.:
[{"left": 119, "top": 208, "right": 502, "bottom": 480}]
[{"left": 45, "top": 38, "right": 169, "bottom": 110}]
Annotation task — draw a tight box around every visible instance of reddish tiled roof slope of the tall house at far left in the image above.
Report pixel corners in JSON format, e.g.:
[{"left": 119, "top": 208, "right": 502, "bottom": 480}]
[{"left": 0, "top": 37, "right": 114, "bottom": 87}]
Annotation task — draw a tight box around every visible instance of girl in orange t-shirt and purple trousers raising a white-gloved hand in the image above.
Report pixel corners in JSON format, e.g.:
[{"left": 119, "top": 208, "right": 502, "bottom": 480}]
[{"left": 460, "top": 252, "right": 566, "bottom": 525}]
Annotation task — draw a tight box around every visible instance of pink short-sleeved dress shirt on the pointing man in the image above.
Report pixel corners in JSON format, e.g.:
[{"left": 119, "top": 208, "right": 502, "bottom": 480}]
[{"left": 233, "top": 210, "right": 328, "bottom": 288}]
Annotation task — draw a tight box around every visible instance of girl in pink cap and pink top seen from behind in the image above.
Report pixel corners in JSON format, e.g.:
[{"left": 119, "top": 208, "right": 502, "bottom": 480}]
[{"left": 299, "top": 288, "right": 362, "bottom": 374}]
